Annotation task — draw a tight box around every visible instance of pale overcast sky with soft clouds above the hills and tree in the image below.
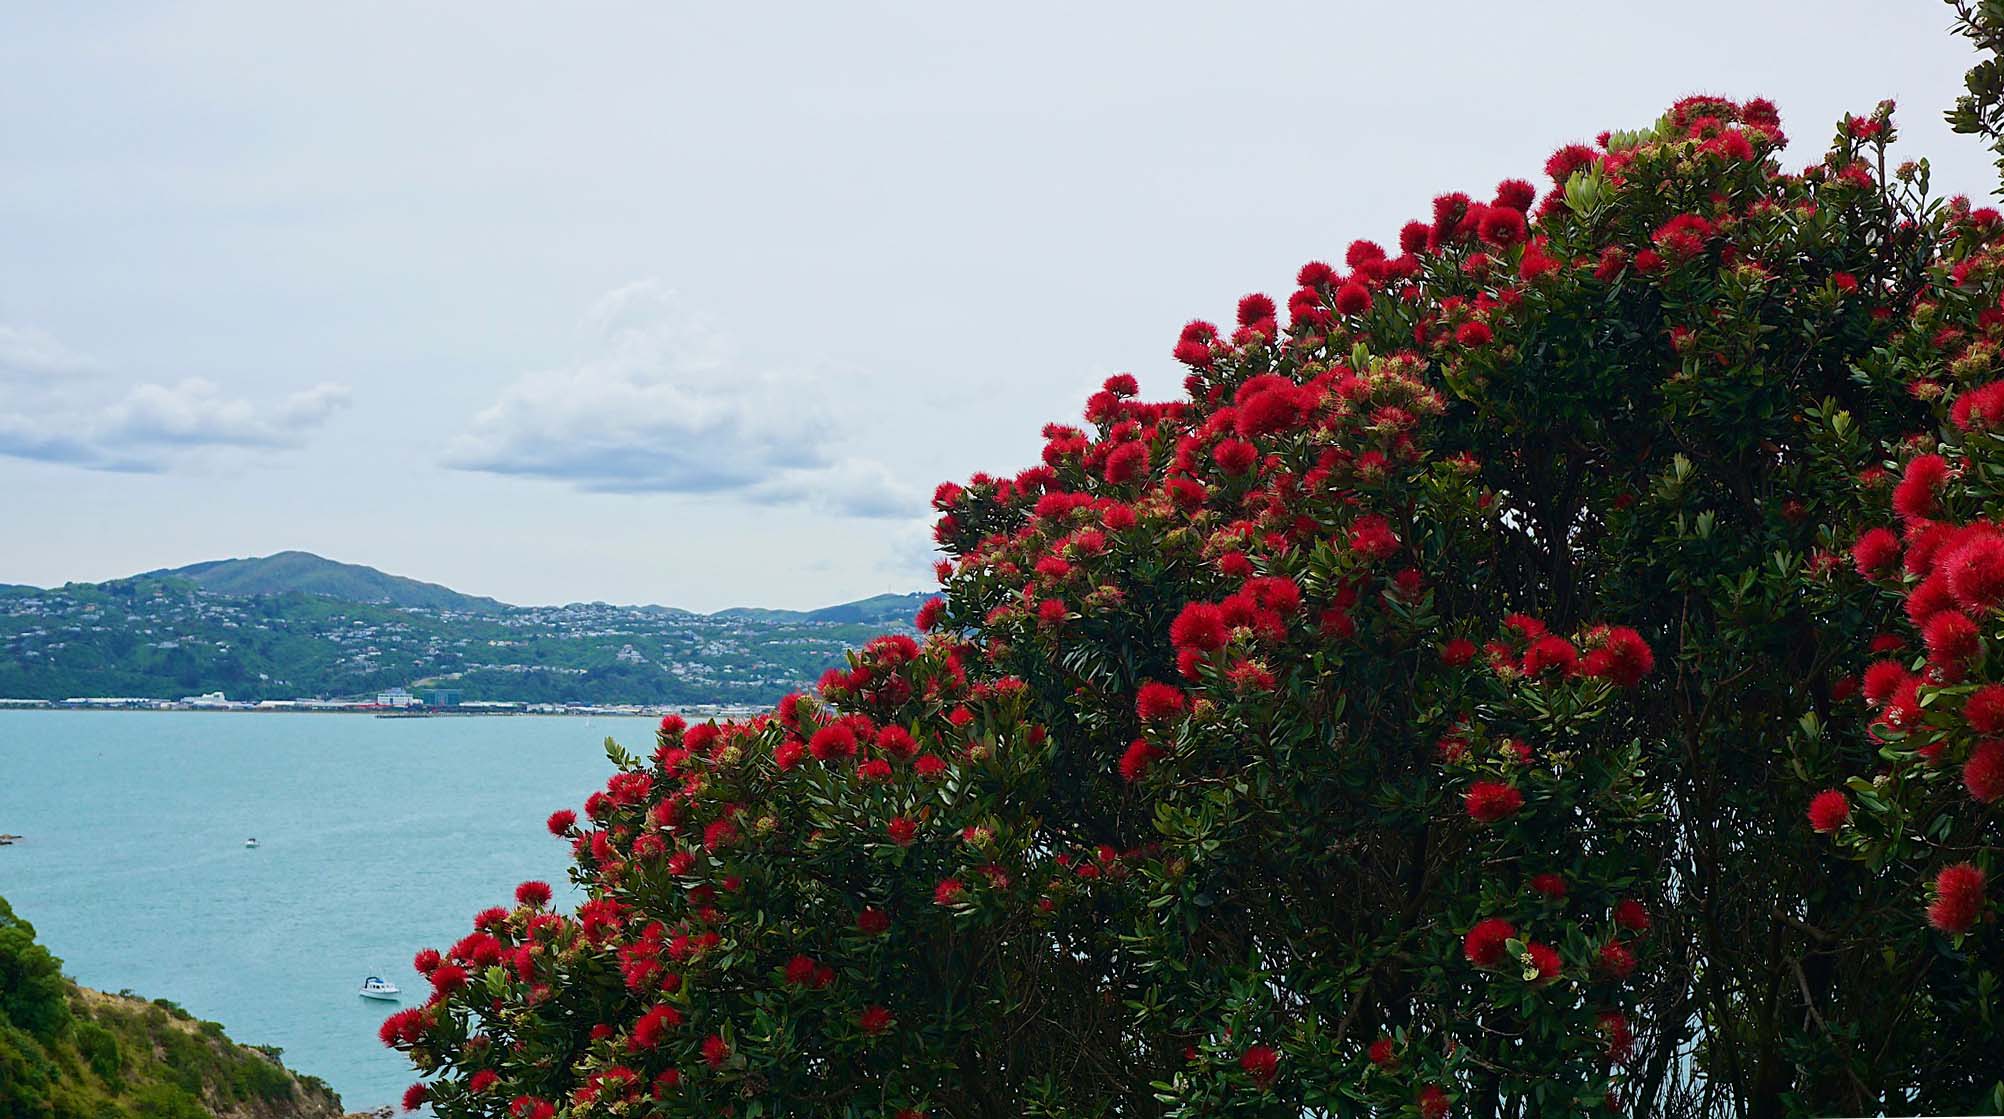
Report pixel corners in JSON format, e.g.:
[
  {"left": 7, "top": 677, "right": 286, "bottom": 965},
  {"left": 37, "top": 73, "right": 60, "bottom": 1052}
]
[{"left": 0, "top": 0, "right": 1990, "bottom": 610}]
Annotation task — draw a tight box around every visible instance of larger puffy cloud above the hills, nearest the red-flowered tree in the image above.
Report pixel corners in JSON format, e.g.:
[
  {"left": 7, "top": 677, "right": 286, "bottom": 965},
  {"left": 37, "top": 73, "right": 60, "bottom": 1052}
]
[{"left": 445, "top": 281, "right": 924, "bottom": 517}]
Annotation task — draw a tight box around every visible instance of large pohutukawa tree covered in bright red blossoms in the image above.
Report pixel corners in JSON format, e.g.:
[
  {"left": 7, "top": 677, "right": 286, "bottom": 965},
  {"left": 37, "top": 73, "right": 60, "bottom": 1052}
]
[{"left": 383, "top": 81, "right": 2004, "bottom": 1119}]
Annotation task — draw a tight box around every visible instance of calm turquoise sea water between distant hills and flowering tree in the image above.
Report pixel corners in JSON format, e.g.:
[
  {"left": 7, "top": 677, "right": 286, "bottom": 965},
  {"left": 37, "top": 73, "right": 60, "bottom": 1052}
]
[{"left": 0, "top": 712, "right": 653, "bottom": 1111}]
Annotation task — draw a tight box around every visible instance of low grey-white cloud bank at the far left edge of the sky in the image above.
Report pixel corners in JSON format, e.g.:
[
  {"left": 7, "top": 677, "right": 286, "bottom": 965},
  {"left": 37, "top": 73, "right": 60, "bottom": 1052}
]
[{"left": 0, "top": 327, "right": 349, "bottom": 473}]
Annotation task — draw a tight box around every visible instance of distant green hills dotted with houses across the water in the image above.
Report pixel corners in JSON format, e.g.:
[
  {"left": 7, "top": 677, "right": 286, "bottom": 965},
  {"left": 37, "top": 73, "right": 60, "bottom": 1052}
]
[{"left": 0, "top": 551, "right": 928, "bottom": 706}]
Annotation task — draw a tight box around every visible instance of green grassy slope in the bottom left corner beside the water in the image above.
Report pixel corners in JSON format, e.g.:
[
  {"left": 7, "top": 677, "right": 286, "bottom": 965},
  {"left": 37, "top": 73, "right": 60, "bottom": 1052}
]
[{"left": 0, "top": 898, "right": 341, "bottom": 1119}]
